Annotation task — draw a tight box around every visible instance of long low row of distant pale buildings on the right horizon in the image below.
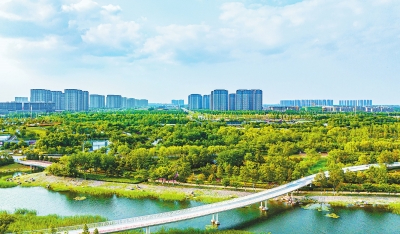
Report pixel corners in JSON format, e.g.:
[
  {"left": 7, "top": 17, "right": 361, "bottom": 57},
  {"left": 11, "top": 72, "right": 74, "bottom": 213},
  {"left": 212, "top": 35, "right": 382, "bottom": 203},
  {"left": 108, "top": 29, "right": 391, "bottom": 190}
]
[{"left": 279, "top": 99, "right": 372, "bottom": 107}]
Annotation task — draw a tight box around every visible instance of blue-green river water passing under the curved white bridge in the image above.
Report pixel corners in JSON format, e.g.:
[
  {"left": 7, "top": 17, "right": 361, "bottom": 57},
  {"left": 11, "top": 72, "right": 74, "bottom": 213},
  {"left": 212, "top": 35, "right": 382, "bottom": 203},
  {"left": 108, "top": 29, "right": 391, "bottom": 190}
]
[{"left": 0, "top": 187, "right": 400, "bottom": 234}]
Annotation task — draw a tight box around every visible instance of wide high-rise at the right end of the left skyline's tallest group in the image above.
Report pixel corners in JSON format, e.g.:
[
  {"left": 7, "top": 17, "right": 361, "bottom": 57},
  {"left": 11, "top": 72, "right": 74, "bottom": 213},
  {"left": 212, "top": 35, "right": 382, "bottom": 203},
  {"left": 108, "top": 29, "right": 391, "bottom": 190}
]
[{"left": 64, "top": 89, "right": 89, "bottom": 111}]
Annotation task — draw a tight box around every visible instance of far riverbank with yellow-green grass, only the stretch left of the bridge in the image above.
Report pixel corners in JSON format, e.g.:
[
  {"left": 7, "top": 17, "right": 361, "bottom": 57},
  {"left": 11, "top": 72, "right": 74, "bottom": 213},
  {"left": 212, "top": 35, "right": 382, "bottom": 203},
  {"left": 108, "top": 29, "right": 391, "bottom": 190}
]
[{"left": 14, "top": 172, "right": 250, "bottom": 203}]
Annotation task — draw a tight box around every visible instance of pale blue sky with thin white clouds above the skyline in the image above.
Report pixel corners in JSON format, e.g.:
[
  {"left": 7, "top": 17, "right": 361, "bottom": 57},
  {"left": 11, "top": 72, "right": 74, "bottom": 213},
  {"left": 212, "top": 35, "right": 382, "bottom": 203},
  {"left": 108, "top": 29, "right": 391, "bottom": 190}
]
[{"left": 0, "top": 0, "right": 400, "bottom": 104}]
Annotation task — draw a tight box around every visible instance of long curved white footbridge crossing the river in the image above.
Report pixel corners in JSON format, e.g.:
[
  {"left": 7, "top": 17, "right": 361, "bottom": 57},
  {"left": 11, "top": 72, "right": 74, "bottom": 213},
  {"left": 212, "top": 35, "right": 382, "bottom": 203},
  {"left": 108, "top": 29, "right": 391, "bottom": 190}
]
[{"left": 26, "top": 162, "right": 400, "bottom": 233}]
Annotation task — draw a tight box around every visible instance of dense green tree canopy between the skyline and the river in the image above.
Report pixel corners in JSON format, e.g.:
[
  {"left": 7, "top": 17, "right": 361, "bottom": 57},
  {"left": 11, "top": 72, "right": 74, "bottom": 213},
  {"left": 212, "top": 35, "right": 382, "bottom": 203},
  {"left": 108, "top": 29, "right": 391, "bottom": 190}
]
[{"left": 0, "top": 111, "right": 400, "bottom": 191}]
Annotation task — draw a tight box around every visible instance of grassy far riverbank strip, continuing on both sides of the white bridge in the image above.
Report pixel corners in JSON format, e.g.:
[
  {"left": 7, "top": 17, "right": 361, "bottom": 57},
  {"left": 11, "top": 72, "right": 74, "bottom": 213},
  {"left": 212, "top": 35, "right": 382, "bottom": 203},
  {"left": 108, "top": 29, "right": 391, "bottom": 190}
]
[{"left": 10, "top": 172, "right": 400, "bottom": 214}]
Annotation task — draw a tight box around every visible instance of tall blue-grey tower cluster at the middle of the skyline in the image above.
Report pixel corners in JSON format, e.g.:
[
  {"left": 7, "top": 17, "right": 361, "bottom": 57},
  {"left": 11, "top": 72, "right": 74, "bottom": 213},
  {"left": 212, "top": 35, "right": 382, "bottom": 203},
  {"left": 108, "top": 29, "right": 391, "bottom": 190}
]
[{"left": 188, "top": 89, "right": 263, "bottom": 111}]
